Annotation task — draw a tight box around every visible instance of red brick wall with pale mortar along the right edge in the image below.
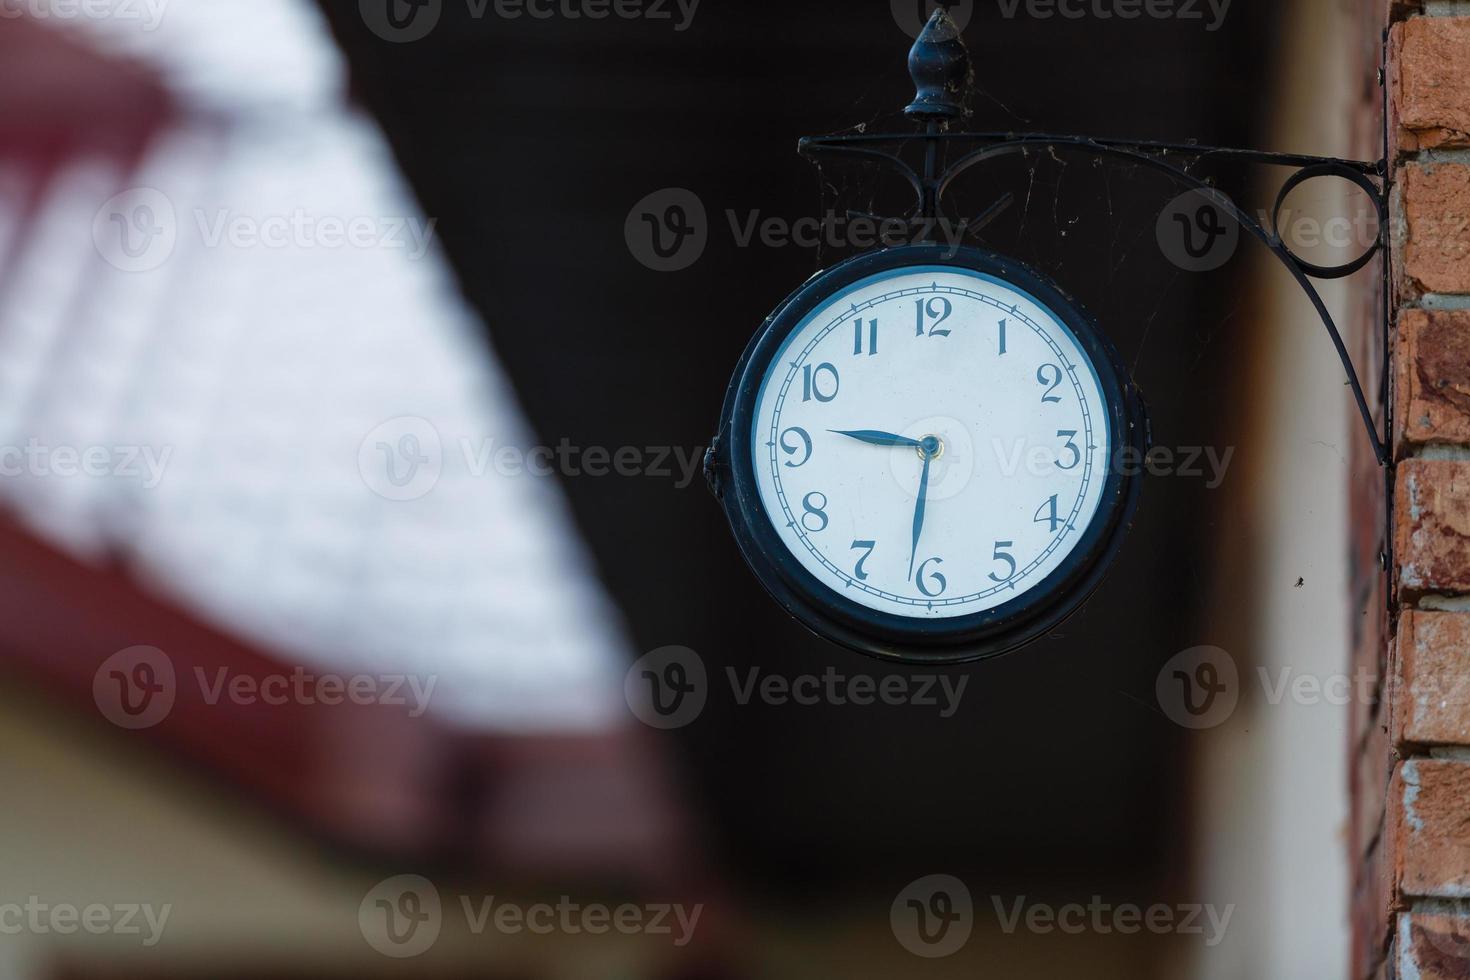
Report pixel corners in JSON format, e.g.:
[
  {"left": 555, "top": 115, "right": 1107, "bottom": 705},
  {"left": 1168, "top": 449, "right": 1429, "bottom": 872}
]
[{"left": 1349, "top": 7, "right": 1470, "bottom": 980}]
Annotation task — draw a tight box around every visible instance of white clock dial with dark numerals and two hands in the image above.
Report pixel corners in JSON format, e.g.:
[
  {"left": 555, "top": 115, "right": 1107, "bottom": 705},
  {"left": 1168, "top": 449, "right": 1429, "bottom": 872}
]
[{"left": 750, "top": 266, "right": 1113, "bottom": 619}]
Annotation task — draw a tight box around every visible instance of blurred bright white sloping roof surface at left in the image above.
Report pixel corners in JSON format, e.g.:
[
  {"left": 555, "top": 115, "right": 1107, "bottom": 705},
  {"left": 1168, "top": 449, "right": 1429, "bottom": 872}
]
[{"left": 0, "top": 0, "right": 629, "bottom": 733}]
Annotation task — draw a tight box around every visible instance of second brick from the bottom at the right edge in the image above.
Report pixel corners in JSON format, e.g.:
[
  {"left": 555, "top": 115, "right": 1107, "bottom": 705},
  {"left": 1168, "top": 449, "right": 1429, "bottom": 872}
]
[{"left": 1389, "top": 758, "right": 1470, "bottom": 899}]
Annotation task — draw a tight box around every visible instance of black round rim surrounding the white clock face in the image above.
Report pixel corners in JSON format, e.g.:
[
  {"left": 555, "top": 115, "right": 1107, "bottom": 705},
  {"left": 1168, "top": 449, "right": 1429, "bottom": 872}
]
[{"left": 711, "top": 244, "right": 1148, "bottom": 664}]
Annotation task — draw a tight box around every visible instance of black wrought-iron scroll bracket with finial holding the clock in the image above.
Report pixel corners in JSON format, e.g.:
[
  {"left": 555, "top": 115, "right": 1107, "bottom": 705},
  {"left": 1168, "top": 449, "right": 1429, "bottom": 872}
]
[{"left": 797, "top": 7, "right": 1391, "bottom": 466}]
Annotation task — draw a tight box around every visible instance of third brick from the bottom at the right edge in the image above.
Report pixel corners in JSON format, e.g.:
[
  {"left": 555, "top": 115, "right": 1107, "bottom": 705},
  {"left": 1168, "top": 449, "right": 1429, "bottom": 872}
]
[{"left": 1392, "top": 610, "right": 1470, "bottom": 746}]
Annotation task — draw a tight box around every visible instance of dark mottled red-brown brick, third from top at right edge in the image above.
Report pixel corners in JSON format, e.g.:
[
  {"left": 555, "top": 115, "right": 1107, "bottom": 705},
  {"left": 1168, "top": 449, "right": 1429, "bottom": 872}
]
[{"left": 1394, "top": 310, "right": 1470, "bottom": 447}]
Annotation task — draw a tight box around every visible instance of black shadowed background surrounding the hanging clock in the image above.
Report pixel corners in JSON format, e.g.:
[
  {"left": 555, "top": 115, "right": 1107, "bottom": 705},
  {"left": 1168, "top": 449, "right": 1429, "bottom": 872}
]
[{"left": 322, "top": 0, "right": 1288, "bottom": 892}]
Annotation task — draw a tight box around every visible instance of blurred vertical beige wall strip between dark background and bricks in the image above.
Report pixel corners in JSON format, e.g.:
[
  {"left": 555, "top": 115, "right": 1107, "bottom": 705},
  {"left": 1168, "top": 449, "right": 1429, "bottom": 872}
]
[{"left": 1189, "top": 0, "right": 1373, "bottom": 980}]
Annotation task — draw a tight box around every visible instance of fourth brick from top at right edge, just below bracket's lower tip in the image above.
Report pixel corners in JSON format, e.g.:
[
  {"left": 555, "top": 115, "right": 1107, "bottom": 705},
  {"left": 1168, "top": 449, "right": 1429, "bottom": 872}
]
[{"left": 1394, "top": 458, "right": 1470, "bottom": 592}]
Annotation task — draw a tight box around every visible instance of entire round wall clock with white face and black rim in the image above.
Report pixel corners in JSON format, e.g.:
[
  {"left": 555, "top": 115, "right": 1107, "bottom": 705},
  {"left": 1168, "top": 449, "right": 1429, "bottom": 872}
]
[{"left": 711, "top": 245, "right": 1145, "bottom": 661}]
